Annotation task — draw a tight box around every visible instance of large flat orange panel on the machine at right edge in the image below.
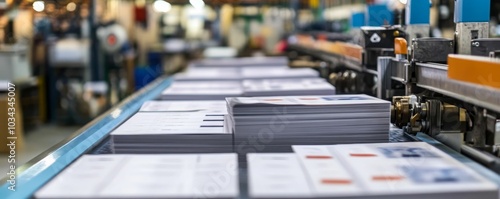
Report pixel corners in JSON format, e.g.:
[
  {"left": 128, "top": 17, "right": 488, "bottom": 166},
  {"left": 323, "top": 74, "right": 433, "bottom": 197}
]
[{"left": 448, "top": 55, "right": 500, "bottom": 88}]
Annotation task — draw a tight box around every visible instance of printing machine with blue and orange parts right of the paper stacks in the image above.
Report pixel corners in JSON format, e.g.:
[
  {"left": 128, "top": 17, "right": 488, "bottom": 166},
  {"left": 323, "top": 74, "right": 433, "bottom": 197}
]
[{"left": 290, "top": 0, "right": 500, "bottom": 173}]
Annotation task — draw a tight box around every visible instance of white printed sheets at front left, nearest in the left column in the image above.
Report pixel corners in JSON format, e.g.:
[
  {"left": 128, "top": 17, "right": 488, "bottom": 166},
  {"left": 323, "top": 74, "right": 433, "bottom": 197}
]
[{"left": 35, "top": 154, "right": 239, "bottom": 199}]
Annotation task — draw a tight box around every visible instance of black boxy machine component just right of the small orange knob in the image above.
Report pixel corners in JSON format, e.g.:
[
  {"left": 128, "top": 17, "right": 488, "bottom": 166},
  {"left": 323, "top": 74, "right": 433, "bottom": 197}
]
[{"left": 411, "top": 38, "right": 455, "bottom": 63}]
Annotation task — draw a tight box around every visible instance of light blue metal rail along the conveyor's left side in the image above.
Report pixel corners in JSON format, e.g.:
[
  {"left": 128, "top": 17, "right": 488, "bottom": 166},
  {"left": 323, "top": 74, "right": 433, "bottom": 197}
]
[{"left": 0, "top": 77, "right": 172, "bottom": 199}]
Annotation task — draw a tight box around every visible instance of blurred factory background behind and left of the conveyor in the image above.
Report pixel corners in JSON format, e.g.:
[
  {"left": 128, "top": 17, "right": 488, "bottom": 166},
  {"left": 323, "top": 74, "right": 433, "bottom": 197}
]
[{"left": 0, "top": 0, "right": 500, "bottom": 183}]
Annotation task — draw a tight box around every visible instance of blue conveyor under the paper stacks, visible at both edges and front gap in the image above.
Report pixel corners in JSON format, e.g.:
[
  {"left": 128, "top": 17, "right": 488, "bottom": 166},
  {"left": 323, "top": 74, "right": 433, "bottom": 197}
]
[{"left": 0, "top": 75, "right": 500, "bottom": 198}]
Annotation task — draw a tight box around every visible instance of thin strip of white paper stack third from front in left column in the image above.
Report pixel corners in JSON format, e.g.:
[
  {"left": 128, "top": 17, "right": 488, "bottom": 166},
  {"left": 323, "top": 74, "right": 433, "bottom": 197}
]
[{"left": 139, "top": 100, "right": 227, "bottom": 115}]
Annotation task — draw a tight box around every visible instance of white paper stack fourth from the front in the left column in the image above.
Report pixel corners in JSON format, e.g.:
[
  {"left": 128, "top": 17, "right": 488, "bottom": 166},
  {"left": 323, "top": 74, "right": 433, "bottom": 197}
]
[{"left": 161, "top": 81, "right": 243, "bottom": 100}]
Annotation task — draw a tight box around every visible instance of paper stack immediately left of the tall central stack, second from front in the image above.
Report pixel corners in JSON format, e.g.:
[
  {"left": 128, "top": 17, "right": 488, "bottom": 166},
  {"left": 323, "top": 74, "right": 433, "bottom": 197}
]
[{"left": 111, "top": 111, "right": 233, "bottom": 154}]
